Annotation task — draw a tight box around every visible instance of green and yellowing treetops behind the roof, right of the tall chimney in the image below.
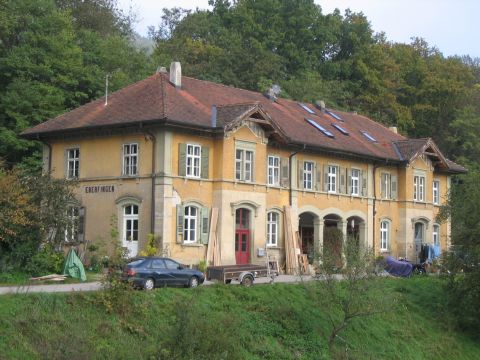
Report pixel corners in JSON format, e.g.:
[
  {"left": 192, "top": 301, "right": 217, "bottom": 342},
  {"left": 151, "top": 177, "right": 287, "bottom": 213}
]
[{"left": 150, "top": 0, "right": 480, "bottom": 167}]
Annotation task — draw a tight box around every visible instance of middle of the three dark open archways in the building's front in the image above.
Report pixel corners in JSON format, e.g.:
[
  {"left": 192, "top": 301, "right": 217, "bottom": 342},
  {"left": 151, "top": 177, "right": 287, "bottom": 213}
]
[{"left": 323, "top": 214, "right": 344, "bottom": 269}]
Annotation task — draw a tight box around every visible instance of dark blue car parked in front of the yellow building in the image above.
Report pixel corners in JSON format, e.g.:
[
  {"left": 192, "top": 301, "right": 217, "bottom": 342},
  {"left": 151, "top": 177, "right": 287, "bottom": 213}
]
[{"left": 123, "top": 257, "right": 205, "bottom": 290}]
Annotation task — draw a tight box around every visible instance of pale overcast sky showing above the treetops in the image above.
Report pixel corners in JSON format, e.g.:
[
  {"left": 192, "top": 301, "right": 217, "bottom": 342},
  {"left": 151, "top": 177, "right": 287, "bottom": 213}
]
[{"left": 118, "top": 0, "right": 480, "bottom": 57}]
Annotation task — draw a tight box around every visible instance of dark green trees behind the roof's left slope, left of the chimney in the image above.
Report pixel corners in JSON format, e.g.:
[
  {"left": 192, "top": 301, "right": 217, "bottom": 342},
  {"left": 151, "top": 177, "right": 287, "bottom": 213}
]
[{"left": 0, "top": 0, "right": 153, "bottom": 166}]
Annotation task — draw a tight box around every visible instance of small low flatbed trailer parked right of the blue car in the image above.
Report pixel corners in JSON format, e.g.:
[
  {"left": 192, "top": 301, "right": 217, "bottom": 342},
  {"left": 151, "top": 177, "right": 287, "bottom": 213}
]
[{"left": 207, "top": 264, "right": 278, "bottom": 287}]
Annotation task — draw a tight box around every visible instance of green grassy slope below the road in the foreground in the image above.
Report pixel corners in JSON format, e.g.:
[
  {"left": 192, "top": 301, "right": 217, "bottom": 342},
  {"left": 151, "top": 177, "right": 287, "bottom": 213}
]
[{"left": 0, "top": 277, "right": 480, "bottom": 360}]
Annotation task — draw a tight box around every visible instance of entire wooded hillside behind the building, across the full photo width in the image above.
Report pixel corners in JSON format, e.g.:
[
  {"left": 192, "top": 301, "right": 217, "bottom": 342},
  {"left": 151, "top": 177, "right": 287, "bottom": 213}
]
[{"left": 0, "top": 0, "right": 480, "bottom": 170}]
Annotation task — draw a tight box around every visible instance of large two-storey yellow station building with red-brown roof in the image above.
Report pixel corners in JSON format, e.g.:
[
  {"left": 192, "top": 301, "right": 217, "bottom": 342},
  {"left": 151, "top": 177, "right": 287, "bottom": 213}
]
[{"left": 24, "top": 63, "right": 465, "bottom": 270}]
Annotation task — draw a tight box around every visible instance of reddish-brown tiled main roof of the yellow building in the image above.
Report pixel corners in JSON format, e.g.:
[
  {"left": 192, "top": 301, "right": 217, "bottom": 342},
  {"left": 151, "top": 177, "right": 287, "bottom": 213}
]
[{"left": 22, "top": 73, "right": 464, "bottom": 172}]
